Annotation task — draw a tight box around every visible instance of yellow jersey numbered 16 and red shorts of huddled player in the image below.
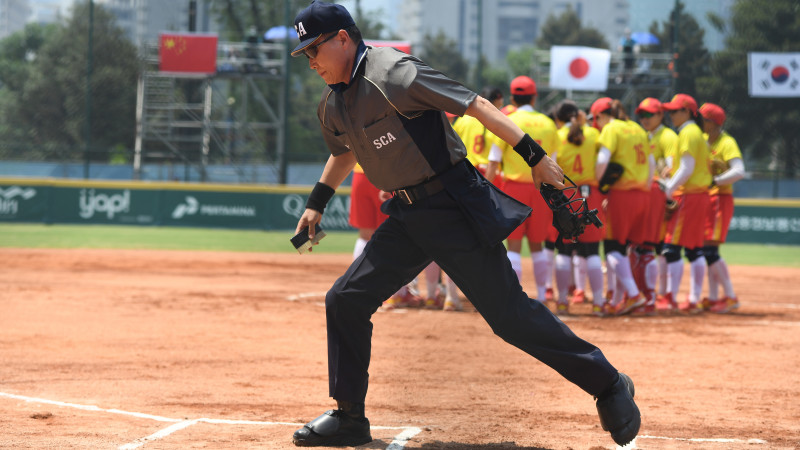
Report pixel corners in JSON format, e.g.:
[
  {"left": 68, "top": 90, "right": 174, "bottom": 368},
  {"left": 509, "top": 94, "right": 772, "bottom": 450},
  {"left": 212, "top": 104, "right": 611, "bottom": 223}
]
[{"left": 597, "top": 119, "right": 650, "bottom": 245}]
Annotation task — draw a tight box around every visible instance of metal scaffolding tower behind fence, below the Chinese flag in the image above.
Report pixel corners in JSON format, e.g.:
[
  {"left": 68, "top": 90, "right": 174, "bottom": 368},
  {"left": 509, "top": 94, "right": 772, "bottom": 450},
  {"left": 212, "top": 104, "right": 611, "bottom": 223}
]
[{"left": 133, "top": 42, "right": 288, "bottom": 182}]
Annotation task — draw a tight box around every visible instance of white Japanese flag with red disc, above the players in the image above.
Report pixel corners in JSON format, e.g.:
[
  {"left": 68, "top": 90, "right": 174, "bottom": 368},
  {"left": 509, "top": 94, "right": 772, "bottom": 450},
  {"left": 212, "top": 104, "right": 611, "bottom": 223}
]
[{"left": 550, "top": 45, "right": 611, "bottom": 91}]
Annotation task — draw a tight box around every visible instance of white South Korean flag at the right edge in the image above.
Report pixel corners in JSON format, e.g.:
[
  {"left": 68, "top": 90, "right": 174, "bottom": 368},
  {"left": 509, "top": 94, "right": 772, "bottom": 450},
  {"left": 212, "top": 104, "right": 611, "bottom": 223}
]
[{"left": 747, "top": 53, "right": 800, "bottom": 97}]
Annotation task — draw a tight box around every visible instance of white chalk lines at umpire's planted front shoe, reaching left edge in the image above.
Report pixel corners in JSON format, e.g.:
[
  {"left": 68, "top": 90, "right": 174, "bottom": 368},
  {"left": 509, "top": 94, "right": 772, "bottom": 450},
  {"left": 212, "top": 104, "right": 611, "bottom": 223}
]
[{"left": 0, "top": 392, "right": 422, "bottom": 450}]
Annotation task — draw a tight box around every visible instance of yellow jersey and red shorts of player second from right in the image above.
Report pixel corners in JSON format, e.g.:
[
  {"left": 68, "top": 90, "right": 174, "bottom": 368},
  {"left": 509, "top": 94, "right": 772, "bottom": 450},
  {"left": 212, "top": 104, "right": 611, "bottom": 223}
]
[{"left": 664, "top": 122, "right": 711, "bottom": 249}]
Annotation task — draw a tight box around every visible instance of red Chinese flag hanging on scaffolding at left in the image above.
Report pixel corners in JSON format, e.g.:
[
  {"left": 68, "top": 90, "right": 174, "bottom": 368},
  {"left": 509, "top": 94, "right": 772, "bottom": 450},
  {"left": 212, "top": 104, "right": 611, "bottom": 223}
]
[{"left": 158, "top": 33, "right": 217, "bottom": 73}]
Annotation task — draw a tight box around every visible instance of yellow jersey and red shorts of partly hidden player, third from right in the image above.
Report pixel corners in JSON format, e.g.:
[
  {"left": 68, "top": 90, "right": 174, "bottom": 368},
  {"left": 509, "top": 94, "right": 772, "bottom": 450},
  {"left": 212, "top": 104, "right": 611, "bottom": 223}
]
[{"left": 644, "top": 125, "right": 678, "bottom": 244}]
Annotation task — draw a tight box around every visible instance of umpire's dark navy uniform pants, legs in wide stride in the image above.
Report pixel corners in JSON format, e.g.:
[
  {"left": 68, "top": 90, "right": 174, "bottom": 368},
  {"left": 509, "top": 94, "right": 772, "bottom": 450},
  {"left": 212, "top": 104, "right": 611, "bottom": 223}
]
[{"left": 325, "top": 170, "right": 617, "bottom": 402}]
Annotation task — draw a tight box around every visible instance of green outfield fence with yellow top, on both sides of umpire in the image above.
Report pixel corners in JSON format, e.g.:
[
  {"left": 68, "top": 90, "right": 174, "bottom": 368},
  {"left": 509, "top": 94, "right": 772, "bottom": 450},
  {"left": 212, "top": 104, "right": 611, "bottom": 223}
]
[{"left": 0, "top": 178, "right": 800, "bottom": 245}]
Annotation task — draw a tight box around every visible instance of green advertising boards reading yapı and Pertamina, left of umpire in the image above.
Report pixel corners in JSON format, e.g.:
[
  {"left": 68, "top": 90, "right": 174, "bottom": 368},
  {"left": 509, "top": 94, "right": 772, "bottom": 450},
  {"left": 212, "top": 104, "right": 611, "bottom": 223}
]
[{"left": 0, "top": 182, "right": 352, "bottom": 231}]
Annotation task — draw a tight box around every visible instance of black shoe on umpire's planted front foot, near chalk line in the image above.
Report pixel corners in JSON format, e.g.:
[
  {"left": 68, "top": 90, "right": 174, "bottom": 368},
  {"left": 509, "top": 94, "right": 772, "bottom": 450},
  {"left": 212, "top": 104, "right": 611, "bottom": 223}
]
[{"left": 292, "top": 409, "right": 372, "bottom": 447}]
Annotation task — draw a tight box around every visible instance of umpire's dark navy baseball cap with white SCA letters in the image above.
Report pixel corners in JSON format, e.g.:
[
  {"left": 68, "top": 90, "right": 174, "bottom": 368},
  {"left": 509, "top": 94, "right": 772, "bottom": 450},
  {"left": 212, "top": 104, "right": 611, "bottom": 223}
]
[{"left": 292, "top": 0, "right": 356, "bottom": 56}]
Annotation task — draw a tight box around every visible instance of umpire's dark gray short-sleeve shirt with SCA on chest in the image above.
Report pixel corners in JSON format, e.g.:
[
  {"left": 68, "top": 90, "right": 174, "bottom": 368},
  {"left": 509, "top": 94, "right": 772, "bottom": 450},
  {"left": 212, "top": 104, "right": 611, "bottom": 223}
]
[{"left": 318, "top": 47, "right": 476, "bottom": 191}]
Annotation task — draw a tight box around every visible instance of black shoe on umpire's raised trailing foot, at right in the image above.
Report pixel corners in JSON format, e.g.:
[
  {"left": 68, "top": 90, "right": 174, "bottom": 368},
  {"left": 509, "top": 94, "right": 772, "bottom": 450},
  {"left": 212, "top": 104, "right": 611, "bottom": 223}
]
[{"left": 597, "top": 373, "right": 642, "bottom": 446}]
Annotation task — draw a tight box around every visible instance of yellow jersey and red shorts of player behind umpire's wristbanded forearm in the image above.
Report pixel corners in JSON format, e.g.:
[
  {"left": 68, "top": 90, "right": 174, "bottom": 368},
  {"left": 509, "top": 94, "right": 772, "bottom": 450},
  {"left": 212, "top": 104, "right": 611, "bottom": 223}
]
[{"left": 493, "top": 109, "right": 558, "bottom": 242}]
